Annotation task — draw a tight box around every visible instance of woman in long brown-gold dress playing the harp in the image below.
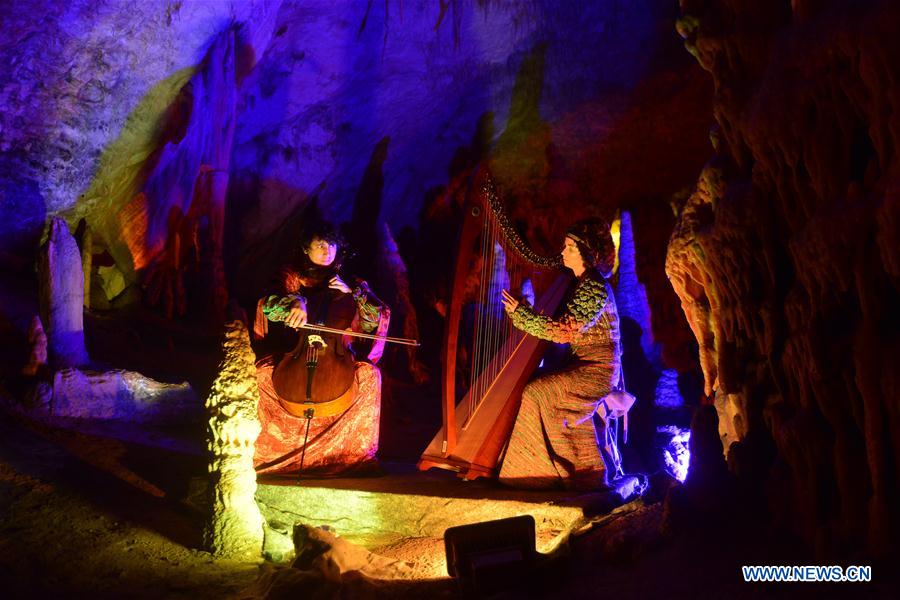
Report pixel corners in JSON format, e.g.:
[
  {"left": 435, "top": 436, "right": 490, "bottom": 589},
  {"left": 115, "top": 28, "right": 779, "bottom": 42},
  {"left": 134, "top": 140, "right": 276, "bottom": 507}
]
[{"left": 499, "top": 220, "right": 621, "bottom": 490}]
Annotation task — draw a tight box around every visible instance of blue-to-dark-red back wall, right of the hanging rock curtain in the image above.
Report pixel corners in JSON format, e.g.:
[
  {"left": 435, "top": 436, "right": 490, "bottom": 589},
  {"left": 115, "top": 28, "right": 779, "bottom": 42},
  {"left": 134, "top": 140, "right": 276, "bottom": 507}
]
[{"left": 223, "top": 0, "right": 711, "bottom": 310}]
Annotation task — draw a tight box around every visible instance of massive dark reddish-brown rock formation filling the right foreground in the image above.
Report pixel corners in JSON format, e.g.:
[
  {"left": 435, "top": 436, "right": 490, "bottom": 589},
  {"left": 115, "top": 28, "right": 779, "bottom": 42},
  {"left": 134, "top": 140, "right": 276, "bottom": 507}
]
[{"left": 666, "top": 0, "right": 900, "bottom": 556}]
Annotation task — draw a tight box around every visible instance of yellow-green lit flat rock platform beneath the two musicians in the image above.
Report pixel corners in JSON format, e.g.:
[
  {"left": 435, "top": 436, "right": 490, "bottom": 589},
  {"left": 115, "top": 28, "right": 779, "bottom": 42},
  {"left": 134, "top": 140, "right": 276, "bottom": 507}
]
[{"left": 256, "top": 466, "right": 584, "bottom": 577}]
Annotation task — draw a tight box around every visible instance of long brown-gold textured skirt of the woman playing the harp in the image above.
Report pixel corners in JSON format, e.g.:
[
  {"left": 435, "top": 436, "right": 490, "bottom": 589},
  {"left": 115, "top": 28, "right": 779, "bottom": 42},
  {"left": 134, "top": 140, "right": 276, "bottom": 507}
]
[{"left": 500, "top": 363, "right": 612, "bottom": 490}]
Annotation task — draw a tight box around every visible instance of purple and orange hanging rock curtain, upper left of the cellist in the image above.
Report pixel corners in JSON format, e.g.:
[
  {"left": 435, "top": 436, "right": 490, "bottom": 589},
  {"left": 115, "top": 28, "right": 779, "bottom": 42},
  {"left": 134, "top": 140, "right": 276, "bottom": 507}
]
[{"left": 134, "top": 28, "right": 239, "bottom": 323}]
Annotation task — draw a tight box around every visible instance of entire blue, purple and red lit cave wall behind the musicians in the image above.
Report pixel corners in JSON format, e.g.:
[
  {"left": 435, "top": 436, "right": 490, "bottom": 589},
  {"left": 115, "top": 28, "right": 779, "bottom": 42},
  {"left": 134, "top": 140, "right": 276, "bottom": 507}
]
[{"left": 0, "top": 0, "right": 710, "bottom": 365}]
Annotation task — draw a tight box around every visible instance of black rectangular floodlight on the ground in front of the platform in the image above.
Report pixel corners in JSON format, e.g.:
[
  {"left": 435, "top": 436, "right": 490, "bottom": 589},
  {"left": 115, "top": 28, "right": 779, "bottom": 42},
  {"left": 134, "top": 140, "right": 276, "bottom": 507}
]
[{"left": 444, "top": 515, "right": 538, "bottom": 589}]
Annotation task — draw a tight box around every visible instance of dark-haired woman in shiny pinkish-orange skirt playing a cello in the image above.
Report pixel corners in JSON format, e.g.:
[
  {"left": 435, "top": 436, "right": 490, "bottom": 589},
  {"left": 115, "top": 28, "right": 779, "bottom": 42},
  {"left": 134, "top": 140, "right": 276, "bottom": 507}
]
[{"left": 254, "top": 222, "right": 390, "bottom": 475}]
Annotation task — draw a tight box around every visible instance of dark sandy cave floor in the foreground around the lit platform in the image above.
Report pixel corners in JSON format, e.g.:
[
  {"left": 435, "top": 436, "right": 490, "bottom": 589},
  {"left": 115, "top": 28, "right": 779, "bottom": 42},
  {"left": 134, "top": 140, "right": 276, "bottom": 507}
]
[{"left": 0, "top": 406, "right": 896, "bottom": 598}]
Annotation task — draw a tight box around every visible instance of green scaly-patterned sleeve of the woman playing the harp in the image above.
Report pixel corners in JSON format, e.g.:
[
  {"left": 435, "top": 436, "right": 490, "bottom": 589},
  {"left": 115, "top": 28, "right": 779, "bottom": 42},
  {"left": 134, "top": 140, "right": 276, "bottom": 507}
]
[{"left": 510, "top": 279, "right": 607, "bottom": 344}]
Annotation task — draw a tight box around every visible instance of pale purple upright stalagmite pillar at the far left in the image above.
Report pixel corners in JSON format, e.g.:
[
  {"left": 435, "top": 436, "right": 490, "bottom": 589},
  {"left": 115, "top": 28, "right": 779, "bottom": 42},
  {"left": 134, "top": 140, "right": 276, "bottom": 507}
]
[{"left": 40, "top": 217, "right": 89, "bottom": 367}]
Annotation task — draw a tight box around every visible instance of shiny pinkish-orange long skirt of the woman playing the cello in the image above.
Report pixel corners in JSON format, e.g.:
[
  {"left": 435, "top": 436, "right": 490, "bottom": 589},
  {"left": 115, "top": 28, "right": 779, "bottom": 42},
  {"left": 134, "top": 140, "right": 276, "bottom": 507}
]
[{"left": 253, "top": 359, "right": 381, "bottom": 476}]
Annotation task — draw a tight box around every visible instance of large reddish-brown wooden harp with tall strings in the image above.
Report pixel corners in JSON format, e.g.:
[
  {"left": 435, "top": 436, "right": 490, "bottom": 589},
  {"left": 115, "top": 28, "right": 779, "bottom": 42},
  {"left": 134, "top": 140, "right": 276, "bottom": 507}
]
[{"left": 419, "top": 168, "right": 571, "bottom": 479}]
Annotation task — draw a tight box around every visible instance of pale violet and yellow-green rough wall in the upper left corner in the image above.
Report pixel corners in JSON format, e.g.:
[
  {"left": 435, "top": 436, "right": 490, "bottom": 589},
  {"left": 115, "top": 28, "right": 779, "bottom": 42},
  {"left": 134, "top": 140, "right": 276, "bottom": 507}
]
[{"left": 0, "top": 0, "right": 279, "bottom": 257}]
